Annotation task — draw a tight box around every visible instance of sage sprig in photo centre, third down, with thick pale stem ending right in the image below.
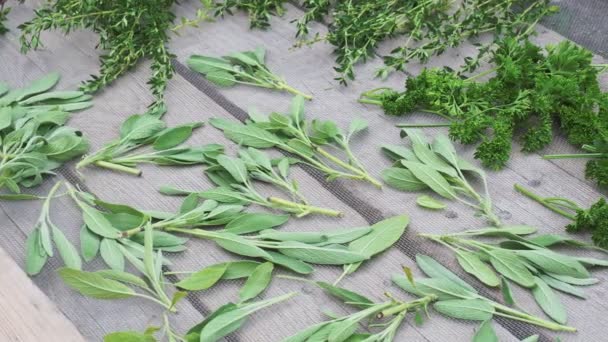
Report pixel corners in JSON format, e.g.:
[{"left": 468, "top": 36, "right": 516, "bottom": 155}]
[{"left": 160, "top": 147, "right": 342, "bottom": 217}]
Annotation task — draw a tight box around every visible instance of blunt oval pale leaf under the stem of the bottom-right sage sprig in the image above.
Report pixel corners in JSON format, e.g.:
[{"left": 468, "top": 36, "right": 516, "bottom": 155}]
[{"left": 433, "top": 299, "right": 495, "bottom": 321}]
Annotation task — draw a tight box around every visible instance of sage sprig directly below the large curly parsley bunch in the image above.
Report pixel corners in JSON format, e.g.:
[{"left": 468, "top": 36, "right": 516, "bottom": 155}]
[{"left": 382, "top": 128, "right": 500, "bottom": 226}]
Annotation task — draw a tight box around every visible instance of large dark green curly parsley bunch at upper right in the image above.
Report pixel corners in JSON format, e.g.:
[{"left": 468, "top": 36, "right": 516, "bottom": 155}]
[{"left": 360, "top": 39, "right": 608, "bottom": 170}]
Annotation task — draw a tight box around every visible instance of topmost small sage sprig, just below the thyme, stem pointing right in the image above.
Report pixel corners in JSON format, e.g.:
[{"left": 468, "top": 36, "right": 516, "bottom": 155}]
[{"left": 187, "top": 47, "right": 312, "bottom": 100}]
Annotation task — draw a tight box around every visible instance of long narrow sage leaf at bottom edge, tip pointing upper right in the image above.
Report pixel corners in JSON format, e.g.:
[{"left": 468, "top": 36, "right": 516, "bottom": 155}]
[{"left": 200, "top": 293, "right": 295, "bottom": 342}]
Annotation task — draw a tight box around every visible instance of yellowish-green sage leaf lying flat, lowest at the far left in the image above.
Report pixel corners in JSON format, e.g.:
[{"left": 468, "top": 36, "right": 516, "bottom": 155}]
[{"left": 58, "top": 267, "right": 135, "bottom": 299}]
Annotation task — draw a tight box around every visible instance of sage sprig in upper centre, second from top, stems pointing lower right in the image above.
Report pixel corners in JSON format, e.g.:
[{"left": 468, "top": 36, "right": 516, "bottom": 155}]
[{"left": 210, "top": 96, "right": 382, "bottom": 188}]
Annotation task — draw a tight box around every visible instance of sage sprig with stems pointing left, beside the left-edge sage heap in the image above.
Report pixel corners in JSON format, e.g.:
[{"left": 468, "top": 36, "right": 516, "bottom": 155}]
[{"left": 76, "top": 107, "right": 224, "bottom": 176}]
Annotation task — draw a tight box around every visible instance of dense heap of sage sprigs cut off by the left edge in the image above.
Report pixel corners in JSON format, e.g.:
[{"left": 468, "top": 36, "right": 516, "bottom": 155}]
[{"left": 0, "top": 73, "right": 91, "bottom": 193}]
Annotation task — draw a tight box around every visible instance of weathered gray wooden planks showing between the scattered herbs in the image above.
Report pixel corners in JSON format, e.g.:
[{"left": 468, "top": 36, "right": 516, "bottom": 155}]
[{"left": 0, "top": 1, "right": 608, "bottom": 341}]
